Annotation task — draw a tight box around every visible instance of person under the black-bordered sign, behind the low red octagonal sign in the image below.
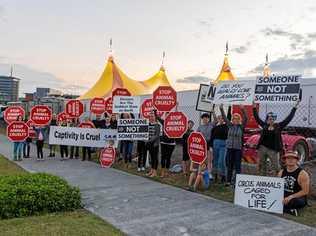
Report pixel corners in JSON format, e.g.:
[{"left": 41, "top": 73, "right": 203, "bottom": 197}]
[{"left": 197, "top": 113, "right": 215, "bottom": 179}]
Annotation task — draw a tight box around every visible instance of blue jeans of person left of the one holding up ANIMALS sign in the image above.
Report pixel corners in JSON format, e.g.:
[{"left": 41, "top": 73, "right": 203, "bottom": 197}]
[{"left": 213, "top": 139, "right": 226, "bottom": 176}]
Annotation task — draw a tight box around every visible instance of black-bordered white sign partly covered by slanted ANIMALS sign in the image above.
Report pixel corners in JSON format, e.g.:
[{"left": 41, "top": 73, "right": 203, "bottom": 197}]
[{"left": 195, "top": 84, "right": 214, "bottom": 112}]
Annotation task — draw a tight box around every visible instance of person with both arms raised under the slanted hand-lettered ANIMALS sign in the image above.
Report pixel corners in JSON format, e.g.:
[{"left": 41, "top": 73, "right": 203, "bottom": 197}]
[{"left": 220, "top": 104, "right": 248, "bottom": 184}]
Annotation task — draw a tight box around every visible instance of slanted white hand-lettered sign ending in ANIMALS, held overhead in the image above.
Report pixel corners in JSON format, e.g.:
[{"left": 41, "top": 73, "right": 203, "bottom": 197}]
[{"left": 214, "top": 80, "right": 256, "bottom": 105}]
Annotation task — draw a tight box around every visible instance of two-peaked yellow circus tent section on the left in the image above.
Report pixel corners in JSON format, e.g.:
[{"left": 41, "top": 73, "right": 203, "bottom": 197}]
[{"left": 79, "top": 56, "right": 170, "bottom": 100}]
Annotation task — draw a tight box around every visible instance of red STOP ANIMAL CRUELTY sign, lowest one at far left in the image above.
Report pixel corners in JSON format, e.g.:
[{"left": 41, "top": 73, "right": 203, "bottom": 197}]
[{"left": 7, "top": 121, "right": 29, "bottom": 142}]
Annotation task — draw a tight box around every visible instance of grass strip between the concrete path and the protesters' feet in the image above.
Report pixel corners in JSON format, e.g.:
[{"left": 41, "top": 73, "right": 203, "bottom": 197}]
[{"left": 93, "top": 155, "right": 316, "bottom": 227}]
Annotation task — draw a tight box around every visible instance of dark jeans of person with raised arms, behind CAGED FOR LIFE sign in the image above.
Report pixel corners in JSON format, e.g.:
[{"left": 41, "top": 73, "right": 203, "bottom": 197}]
[{"left": 226, "top": 148, "right": 242, "bottom": 183}]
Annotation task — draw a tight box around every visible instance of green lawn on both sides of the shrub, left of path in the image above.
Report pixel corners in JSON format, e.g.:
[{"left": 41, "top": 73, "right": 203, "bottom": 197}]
[{"left": 0, "top": 155, "right": 124, "bottom": 236}]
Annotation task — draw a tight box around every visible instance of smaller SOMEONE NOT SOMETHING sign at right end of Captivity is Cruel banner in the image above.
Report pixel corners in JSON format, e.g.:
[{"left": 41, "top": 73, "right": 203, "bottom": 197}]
[{"left": 117, "top": 119, "right": 149, "bottom": 140}]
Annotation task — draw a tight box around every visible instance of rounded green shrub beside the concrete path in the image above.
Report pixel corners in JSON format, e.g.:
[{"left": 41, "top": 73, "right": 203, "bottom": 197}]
[{"left": 0, "top": 173, "right": 82, "bottom": 218}]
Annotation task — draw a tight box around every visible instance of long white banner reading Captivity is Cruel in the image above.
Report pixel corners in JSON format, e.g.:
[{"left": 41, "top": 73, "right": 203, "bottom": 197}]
[{"left": 49, "top": 126, "right": 117, "bottom": 148}]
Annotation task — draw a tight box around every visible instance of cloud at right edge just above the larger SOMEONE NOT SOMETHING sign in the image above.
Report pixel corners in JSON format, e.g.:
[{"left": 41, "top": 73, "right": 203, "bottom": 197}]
[{"left": 250, "top": 49, "right": 316, "bottom": 76}]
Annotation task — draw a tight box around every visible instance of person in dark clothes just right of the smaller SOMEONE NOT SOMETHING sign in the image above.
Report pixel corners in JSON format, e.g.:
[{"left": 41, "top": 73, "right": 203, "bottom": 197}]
[{"left": 145, "top": 113, "right": 160, "bottom": 177}]
